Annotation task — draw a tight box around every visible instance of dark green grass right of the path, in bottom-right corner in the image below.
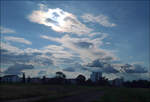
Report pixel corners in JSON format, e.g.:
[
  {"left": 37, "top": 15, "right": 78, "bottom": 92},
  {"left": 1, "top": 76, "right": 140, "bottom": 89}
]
[{"left": 94, "top": 88, "right": 150, "bottom": 102}]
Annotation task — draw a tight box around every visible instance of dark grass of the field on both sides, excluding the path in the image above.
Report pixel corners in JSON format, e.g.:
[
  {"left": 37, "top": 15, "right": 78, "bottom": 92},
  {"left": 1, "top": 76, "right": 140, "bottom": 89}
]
[{"left": 0, "top": 84, "right": 150, "bottom": 102}]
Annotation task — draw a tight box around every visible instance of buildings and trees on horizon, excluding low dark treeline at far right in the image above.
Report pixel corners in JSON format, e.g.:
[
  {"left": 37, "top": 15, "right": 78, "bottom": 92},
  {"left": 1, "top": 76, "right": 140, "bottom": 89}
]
[{"left": 0, "top": 72, "right": 124, "bottom": 86}]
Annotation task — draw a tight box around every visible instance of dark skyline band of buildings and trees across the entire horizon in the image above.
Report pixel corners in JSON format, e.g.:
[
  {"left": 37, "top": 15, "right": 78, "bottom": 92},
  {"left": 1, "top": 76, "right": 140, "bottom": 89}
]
[{"left": 0, "top": 72, "right": 150, "bottom": 88}]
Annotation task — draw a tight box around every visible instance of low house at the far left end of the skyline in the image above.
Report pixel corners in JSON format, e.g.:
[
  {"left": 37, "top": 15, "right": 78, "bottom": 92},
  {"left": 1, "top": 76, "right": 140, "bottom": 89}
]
[{"left": 1, "top": 75, "right": 21, "bottom": 83}]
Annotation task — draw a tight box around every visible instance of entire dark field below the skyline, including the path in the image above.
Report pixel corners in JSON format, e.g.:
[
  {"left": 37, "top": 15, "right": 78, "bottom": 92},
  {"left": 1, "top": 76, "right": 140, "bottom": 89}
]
[{"left": 0, "top": 84, "right": 150, "bottom": 102}]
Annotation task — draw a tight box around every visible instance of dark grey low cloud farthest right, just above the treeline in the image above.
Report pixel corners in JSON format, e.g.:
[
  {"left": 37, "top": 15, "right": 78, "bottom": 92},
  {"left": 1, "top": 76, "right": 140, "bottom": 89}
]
[{"left": 121, "top": 64, "right": 148, "bottom": 73}]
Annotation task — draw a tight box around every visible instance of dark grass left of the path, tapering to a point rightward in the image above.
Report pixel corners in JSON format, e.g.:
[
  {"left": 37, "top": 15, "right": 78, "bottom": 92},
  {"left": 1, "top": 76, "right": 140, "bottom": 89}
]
[{"left": 0, "top": 84, "right": 98, "bottom": 100}]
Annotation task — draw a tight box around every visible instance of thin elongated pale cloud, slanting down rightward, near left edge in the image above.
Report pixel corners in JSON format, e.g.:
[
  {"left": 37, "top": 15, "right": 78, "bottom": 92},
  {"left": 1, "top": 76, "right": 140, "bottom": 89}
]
[{"left": 4, "top": 36, "right": 32, "bottom": 45}]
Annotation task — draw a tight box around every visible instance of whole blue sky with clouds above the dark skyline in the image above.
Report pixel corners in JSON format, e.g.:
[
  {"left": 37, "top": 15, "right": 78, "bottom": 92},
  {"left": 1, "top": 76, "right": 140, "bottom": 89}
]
[{"left": 0, "top": 0, "right": 150, "bottom": 80}]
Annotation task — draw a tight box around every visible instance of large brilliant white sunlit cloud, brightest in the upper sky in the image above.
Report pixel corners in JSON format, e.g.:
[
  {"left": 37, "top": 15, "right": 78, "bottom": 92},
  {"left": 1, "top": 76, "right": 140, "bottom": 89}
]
[{"left": 28, "top": 6, "right": 92, "bottom": 35}]
